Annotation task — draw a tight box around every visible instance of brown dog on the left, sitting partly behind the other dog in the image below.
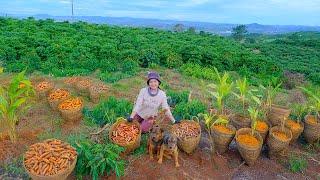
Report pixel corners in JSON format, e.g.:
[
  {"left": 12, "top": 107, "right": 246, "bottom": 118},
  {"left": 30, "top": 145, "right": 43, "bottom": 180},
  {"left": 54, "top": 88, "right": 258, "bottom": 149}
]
[{"left": 148, "top": 125, "right": 163, "bottom": 160}]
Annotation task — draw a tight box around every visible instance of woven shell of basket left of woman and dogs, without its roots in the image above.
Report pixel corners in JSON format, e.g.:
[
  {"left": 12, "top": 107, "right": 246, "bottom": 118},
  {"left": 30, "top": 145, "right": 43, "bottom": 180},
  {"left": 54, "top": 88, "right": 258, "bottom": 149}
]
[{"left": 109, "top": 119, "right": 141, "bottom": 155}]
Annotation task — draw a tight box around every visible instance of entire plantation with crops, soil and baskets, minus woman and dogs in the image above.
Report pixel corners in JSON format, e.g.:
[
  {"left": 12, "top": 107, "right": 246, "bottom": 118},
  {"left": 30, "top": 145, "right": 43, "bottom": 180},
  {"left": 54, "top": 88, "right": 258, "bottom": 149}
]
[{"left": 0, "top": 18, "right": 320, "bottom": 179}]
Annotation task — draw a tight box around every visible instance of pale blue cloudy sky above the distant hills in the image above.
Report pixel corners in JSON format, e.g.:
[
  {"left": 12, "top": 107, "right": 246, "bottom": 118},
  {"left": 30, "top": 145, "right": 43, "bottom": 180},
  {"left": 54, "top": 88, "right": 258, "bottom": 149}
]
[{"left": 0, "top": 0, "right": 320, "bottom": 25}]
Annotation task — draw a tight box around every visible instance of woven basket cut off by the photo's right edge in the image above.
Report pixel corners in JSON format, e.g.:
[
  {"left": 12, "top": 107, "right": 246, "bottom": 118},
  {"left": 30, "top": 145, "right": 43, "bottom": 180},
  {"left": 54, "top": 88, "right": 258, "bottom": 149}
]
[{"left": 303, "top": 115, "right": 320, "bottom": 144}]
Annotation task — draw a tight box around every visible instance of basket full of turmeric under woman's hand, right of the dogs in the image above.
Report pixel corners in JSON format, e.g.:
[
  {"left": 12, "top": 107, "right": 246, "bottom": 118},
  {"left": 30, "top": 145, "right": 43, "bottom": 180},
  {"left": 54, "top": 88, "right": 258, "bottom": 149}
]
[{"left": 171, "top": 120, "right": 201, "bottom": 154}]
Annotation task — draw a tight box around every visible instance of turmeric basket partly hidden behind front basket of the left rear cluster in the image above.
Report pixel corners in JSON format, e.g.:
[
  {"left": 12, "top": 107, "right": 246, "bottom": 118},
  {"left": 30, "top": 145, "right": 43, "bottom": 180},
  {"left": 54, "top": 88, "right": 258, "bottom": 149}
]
[{"left": 48, "top": 89, "right": 70, "bottom": 110}]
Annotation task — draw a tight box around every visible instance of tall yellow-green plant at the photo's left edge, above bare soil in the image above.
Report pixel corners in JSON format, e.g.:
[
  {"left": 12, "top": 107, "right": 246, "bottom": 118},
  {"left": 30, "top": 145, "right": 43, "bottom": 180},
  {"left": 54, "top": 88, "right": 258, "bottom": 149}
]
[{"left": 0, "top": 71, "right": 34, "bottom": 142}]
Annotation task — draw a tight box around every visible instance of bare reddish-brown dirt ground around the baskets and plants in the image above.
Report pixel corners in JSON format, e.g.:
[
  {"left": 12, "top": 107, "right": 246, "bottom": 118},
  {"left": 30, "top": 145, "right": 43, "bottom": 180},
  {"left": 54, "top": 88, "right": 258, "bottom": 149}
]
[{"left": 0, "top": 72, "right": 320, "bottom": 180}]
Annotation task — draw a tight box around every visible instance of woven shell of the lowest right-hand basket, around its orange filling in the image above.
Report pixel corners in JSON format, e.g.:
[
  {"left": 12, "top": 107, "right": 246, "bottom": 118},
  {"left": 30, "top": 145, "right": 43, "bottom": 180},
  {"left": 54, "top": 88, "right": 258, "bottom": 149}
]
[{"left": 235, "top": 128, "right": 263, "bottom": 166}]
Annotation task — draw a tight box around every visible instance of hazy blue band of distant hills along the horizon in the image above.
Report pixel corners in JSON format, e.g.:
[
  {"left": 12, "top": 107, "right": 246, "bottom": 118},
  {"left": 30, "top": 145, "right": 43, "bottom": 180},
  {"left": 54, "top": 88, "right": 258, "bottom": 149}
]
[{"left": 0, "top": 13, "right": 320, "bottom": 35}]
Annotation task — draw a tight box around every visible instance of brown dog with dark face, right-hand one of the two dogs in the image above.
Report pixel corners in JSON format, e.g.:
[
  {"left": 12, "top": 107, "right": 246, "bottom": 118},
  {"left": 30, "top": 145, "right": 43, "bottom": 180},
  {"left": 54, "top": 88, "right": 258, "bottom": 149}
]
[{"left": 158, "top": 132, "right": 180, "bottom": 167}]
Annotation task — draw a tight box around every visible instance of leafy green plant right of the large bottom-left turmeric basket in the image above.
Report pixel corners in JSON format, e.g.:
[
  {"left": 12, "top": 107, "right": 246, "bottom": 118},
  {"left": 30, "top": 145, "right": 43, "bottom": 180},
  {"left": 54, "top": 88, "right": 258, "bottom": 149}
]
[{"left": 70, "top": 137, "right": 125, "bottom": 180}]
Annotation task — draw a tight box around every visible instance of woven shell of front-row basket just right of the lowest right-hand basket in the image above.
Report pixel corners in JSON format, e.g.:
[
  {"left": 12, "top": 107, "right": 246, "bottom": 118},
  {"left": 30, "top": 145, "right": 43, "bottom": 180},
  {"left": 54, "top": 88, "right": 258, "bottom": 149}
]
[{"left": 267, "top": 126, "right": 292, "bottom": 158}]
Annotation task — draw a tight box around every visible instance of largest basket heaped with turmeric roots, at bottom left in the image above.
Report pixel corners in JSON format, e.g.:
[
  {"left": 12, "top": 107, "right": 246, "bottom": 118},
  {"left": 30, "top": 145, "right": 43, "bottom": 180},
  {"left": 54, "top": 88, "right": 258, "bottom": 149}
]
[{"left": 23, "top": 139, "right": 77, "bottom": 180}]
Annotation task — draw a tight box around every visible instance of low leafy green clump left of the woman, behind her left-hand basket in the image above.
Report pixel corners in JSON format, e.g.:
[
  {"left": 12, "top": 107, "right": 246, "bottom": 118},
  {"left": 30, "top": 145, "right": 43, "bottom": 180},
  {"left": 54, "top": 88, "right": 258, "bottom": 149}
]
[{"left": 83, "top": 96, "right": 133, "bottom": 126}]
